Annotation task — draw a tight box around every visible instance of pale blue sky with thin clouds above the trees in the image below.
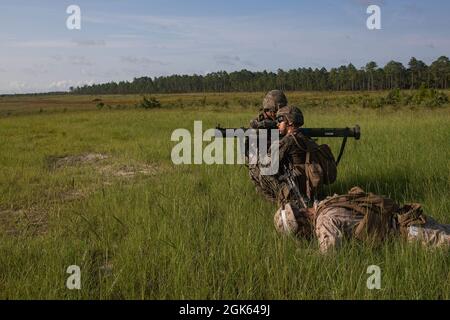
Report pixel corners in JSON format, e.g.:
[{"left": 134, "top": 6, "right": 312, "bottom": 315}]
[{"left": 0, "top": 0, "right": 450, "bottom": 94}]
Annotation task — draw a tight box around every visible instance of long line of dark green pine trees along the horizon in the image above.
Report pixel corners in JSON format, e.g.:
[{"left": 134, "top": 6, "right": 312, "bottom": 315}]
[{"left": 70, "top": 56, "right": 450, "bottom": 94}]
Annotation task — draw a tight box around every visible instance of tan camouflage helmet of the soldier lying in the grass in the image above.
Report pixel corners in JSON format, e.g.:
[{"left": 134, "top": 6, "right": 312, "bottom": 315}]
[{"left": 273, "top": 202, "right": 313, "bottom": 238}]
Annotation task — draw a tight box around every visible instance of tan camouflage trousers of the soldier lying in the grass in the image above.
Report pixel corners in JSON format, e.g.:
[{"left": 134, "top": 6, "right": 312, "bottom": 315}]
[{"left": 407, "top": 217, "right": 450, "bottom": 247}]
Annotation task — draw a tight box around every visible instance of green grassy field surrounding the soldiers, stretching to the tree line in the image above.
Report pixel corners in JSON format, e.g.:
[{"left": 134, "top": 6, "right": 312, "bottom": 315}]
[{"left": 0, "top": 93, "right": 450, "bottom": 299}]
